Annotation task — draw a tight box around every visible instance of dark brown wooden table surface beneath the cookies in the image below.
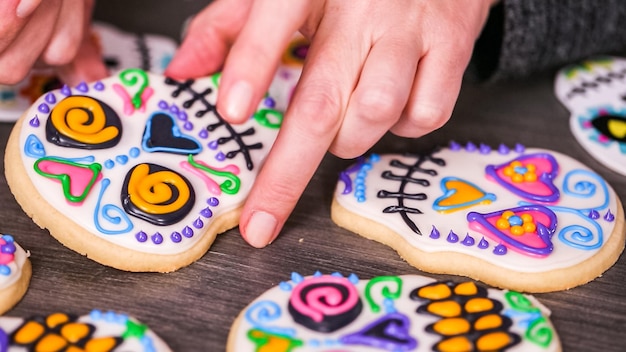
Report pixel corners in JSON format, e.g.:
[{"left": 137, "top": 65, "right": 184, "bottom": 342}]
[{"left": 0, "top": 0, "right": 626, "bottom": 352}]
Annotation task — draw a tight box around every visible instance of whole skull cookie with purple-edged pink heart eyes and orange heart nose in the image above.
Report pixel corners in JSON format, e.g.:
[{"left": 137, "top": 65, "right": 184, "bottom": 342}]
[{"left": 332, "top": 143, "right": 624, "bottom": 292}]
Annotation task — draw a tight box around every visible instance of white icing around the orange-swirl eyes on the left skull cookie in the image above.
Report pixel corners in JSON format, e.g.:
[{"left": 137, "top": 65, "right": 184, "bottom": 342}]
[{"left": 14, "top": 71, "right": 282, "bottom": 254}]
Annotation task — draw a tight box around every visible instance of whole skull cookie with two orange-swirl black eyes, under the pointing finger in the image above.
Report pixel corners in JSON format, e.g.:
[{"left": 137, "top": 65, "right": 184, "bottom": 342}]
[{"left": 5, "top": 69, "right": 282, "bottom": 272}]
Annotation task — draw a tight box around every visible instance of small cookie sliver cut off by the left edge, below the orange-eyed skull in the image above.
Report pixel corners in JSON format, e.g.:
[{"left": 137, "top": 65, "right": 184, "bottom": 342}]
[{"left": 0, "top": 234, "right": 31, "bottom": 314}]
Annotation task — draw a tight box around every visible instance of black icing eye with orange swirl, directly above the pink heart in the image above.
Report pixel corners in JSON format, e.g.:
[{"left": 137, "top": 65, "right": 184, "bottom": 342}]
[{"left": 46, "top": 96, "right": 122, "bottom": 149}]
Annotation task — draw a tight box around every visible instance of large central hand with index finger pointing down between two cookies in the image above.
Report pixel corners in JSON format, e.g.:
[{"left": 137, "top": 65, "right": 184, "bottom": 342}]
[{"left": 166, "top": 0, "right": 493, "bottom": 247}]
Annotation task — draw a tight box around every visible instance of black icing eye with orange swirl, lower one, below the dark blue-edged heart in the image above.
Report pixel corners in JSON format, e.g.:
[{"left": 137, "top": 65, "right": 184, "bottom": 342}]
[{"left": 122, "top": 164, "right": 195, "bottom": 225}]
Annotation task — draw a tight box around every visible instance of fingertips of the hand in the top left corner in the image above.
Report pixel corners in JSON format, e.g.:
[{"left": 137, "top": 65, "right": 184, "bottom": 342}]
[{"left": 0, "top": 0, "right": 107, "bottom": 85}]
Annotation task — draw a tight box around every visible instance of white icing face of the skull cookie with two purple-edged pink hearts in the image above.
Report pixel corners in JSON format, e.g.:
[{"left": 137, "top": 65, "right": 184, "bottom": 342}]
[{"left": 335, "top": 143, "right": 617, "bottom": 273}]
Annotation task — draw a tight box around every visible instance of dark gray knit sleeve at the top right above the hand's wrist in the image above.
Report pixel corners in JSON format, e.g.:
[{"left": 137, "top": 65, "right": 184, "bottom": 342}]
[{"left": 470, "top": 0, "right": 626, "bottom": 80}]
